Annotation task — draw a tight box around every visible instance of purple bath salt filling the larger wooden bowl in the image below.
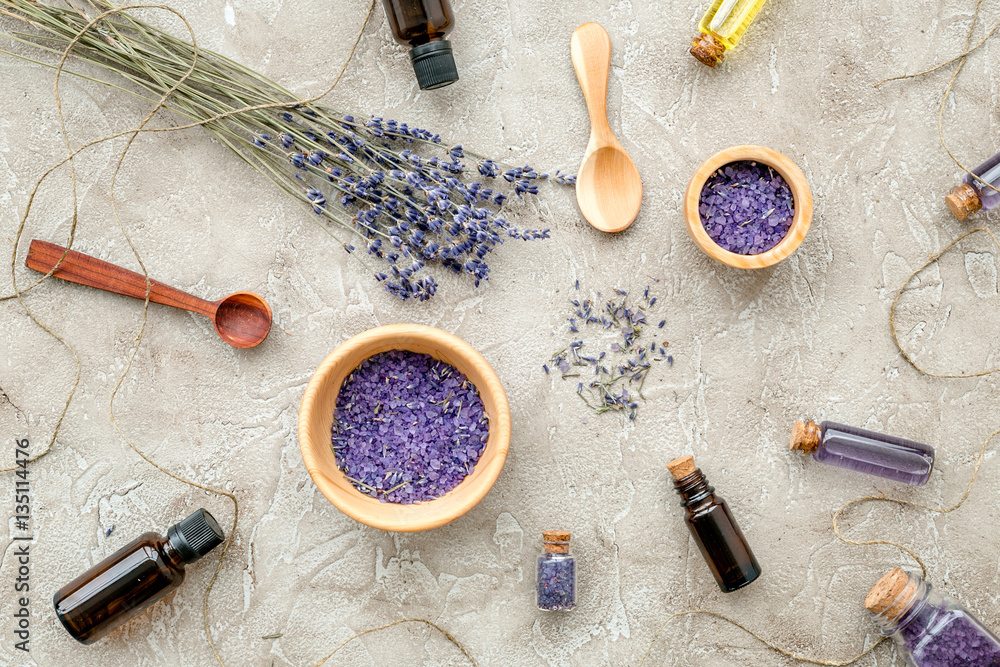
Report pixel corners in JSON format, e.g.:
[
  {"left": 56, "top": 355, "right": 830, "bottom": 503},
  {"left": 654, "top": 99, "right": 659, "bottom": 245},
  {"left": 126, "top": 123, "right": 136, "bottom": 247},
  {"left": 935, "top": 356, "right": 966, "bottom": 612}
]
[{"left": 331, "top": 350, "right": 489, "bottom": 504}]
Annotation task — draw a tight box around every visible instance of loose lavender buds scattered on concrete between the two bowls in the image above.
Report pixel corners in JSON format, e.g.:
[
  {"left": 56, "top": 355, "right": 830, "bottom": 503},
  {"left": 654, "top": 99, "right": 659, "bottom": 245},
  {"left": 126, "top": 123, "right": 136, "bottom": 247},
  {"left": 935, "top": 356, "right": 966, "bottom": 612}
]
[{"left": 542, "top": 281, "right": 673, "bottom": 420}]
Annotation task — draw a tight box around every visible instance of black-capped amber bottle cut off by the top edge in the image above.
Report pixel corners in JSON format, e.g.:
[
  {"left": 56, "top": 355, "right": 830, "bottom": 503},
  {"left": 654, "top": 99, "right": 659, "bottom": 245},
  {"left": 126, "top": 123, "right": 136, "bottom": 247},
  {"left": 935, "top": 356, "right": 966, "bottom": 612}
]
[{"left": 383, "top": 0, "right": 458, "bottom": 90}]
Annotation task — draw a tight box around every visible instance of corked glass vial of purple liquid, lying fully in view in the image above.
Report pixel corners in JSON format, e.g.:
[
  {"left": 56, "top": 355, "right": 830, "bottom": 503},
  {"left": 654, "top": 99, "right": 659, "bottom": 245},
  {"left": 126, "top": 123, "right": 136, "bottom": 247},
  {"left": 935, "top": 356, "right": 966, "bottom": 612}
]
[{"left": 790, "top": 421, "right": 934, "bottom": 486}]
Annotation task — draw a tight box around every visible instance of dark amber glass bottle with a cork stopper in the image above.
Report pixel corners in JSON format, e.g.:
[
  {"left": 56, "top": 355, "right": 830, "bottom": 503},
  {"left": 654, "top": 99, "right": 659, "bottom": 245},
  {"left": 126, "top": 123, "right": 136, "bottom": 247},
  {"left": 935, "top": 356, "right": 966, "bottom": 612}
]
[{"left": 667, "top": 456, "right": 760, "bottom": 593}]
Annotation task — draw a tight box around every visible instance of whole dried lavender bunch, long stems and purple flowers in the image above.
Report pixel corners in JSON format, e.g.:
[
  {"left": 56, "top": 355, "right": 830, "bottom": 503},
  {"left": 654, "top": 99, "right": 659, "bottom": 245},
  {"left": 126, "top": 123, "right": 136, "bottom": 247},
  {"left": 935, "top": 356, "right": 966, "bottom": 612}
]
[{"left": 0, "top": 0, "right": 575, "bottom": 300}]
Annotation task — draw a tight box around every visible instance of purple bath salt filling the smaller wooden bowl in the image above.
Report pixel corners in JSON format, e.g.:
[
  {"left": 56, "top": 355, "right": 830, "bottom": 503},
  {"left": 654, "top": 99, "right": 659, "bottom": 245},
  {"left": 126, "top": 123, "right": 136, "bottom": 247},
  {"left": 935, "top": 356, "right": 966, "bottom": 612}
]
[{"left": 698, "top": 161, "right": 795, "bottom": 255}]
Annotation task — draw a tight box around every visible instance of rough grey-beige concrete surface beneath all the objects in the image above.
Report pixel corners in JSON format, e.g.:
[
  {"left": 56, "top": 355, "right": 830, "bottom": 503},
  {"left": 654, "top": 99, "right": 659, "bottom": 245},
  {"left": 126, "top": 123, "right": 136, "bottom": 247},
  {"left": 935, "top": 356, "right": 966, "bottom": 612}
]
[{"left": 0, "top": 0, "right": 1000, "bottom": 667}]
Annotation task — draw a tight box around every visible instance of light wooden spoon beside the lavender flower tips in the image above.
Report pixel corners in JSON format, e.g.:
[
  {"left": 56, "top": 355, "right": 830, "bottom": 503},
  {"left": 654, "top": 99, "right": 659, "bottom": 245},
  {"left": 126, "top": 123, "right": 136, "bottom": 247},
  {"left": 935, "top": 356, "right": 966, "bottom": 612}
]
[{"left": 570, "top": 23, "right": 642, "bottom": 232}]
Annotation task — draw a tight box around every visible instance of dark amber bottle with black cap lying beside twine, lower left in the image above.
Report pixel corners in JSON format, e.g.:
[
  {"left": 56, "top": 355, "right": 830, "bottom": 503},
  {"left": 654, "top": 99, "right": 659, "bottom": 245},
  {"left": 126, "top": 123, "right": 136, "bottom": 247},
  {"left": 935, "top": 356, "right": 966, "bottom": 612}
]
[{"left": 53, "top": 509, "right": 225, "bottom": 644}]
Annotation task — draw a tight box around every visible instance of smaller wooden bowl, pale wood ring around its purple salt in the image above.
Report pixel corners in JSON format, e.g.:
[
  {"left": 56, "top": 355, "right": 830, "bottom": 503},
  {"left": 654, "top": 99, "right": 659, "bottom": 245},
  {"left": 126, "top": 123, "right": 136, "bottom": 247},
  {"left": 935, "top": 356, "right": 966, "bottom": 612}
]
[{"left": 684, "top": 146, "right": 812, "bottom": 269}]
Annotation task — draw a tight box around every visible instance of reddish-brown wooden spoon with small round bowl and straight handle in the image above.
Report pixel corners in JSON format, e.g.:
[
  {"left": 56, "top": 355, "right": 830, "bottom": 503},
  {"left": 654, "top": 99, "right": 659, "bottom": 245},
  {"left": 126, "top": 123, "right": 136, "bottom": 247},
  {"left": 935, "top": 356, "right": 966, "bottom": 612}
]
[{"left": 24, "top": 239, "right": 271, "bottom": 348}]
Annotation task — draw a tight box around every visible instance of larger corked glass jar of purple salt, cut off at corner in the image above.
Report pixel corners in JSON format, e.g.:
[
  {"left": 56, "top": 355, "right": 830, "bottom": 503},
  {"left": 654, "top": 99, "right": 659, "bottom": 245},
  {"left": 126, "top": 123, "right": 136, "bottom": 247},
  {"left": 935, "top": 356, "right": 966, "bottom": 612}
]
[{"left": 865, "top": 567, "right": 1000, "bottom": 667}]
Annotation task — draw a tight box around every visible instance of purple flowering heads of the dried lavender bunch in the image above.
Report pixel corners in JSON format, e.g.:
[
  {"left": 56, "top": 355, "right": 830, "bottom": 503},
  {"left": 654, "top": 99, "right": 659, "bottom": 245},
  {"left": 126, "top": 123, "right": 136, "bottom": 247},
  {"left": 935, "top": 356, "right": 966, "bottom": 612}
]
[{"left": 242, "top": 113, "right": 572, "bottom": 300}]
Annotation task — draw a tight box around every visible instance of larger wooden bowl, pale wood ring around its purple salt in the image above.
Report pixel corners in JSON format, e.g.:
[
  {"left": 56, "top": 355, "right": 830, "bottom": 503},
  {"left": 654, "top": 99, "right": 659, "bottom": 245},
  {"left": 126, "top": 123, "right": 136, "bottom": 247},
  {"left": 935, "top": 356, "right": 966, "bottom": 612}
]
[{"left": 299, "top": 324, "right": 510, "bottom": 533}]
